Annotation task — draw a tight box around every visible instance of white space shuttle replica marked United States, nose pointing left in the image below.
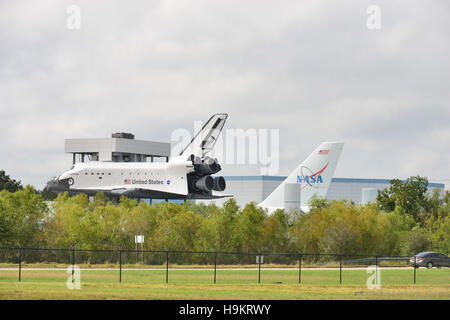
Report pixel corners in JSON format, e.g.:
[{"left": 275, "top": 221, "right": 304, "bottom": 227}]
[{"left": 47, "top": 114, "right": 231, "bottom": 200}]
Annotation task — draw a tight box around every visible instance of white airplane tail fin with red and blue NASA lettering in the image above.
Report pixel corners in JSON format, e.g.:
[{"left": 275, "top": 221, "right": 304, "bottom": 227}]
[{"left": 259, "top": 142, "right": 344, "bottom": 212}]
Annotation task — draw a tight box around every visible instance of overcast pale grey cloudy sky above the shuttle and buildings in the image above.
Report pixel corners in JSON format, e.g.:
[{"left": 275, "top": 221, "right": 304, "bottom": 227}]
[{"left": 0, "top": 0, "right": 450, "bottom": 188}]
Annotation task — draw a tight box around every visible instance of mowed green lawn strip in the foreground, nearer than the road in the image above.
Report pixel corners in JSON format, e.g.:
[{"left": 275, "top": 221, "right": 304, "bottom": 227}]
[{"left": 0, "top": 268, "right": 450, "bottom": 300}]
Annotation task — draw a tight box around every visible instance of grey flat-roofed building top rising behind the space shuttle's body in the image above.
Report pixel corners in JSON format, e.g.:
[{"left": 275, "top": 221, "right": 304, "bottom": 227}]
[{"left": 64, "top": 133, "right": 170, "bottom": 163}]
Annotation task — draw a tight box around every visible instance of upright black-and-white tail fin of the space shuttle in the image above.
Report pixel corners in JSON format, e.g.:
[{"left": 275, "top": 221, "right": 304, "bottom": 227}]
[{"left": 179, "top": 113, "right": 228, "bottom": 158}]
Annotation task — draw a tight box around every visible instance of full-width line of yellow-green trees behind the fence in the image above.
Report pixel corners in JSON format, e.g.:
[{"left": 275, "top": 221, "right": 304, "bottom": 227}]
[{"left": 0, "top": 172, "right": 450, "bottom": 256}]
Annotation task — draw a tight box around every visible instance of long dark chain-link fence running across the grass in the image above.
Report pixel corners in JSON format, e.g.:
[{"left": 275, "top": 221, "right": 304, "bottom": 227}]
[{"left": 0, "top": 248, "right": 450, "bottom": 285}]
